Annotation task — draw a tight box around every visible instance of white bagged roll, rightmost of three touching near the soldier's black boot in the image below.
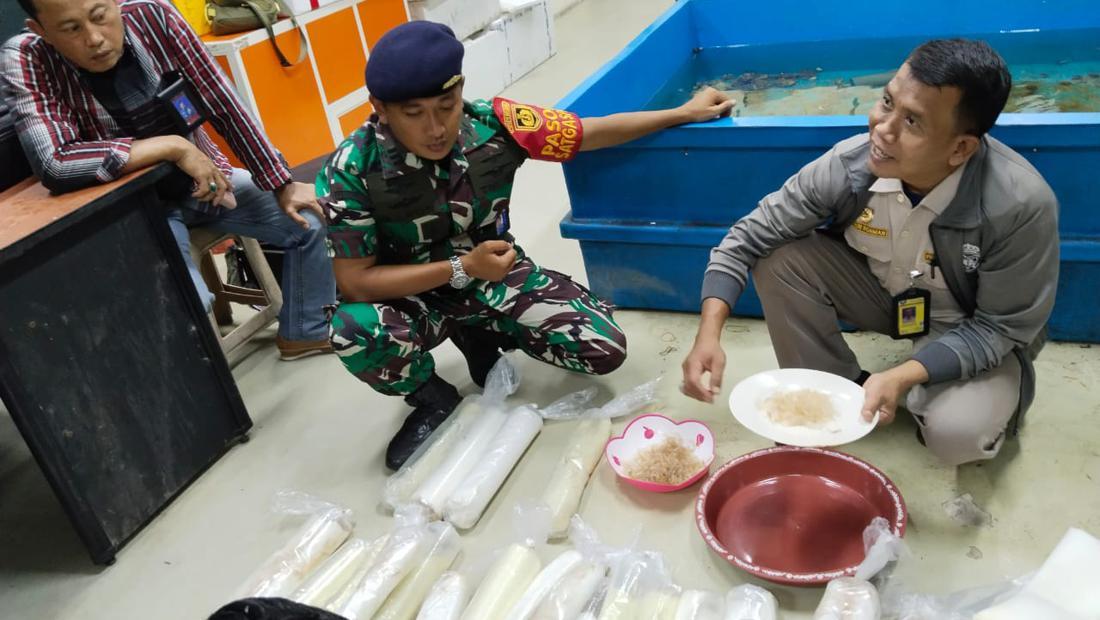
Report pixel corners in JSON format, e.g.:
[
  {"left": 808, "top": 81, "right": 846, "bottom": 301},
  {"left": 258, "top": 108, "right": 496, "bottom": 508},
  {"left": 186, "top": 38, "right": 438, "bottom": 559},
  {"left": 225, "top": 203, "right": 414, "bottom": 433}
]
[{"left": 443, "top": 407, "right": 542, "bottom": 530}]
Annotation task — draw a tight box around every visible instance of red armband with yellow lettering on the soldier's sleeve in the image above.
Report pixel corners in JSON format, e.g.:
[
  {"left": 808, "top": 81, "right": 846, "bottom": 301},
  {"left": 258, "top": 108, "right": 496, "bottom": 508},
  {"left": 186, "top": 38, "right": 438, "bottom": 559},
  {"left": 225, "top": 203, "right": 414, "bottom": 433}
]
[{"left": 493, "top": 97, "right": 584, "bottom": 162}]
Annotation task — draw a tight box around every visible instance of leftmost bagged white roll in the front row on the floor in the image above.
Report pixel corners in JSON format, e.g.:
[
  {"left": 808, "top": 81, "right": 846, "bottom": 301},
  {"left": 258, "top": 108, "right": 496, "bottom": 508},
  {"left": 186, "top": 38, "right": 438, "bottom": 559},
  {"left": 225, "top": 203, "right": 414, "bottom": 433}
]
[{"left": 237, "top": 490, "right": 355, "bottom": 598}]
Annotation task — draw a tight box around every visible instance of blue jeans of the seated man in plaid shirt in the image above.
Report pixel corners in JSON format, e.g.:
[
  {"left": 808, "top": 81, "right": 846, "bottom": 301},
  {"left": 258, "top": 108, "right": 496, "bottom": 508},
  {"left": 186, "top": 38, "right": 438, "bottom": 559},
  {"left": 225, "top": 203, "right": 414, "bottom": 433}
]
[{"left": 168, "top": 168, "right": 337, "bottom": 341}]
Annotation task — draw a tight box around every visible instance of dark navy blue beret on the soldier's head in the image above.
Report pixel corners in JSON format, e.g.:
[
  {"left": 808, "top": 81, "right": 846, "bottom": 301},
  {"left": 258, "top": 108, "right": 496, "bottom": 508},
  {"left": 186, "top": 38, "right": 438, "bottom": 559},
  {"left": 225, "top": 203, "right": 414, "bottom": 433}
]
[{"left": 366, "top": 21, "right": 465, "bottom": 102}]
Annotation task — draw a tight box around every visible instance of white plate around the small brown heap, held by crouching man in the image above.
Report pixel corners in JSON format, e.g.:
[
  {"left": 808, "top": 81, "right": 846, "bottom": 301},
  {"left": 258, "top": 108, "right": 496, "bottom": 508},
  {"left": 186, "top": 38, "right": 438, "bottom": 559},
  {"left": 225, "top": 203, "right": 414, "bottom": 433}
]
[{"left": 729, "top": 368, "right": 879, "bottom": 447}]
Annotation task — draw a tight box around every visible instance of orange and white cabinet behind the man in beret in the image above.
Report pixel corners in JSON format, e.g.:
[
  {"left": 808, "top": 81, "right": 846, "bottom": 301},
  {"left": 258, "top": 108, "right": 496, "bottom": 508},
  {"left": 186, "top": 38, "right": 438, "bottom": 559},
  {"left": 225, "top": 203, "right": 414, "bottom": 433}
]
[{"left": 202, "top": 0, "right": 408, "bottom": 168}]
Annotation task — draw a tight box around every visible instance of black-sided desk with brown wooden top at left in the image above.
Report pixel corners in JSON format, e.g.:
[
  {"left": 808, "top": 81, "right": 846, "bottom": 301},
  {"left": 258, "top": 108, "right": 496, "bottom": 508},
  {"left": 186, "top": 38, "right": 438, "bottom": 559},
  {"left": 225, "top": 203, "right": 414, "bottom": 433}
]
[{"left": 0, "top": 166, "right": 252, "bottom": 564}]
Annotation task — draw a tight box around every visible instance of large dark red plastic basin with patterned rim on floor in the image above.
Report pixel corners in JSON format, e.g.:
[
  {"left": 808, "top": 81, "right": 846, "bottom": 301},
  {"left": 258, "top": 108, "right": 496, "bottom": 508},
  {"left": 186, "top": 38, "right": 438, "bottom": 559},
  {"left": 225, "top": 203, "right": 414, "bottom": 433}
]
[{"left": 695, "top": 446, "right": 906, "bottom": 586}]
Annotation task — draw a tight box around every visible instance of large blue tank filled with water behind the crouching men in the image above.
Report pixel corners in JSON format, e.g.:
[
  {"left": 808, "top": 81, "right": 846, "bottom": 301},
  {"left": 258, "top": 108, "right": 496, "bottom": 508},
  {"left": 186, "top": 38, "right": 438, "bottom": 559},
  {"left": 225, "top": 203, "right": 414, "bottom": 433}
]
[{"left": 560, "top": 0, "right": 1100, "bottom": 342}]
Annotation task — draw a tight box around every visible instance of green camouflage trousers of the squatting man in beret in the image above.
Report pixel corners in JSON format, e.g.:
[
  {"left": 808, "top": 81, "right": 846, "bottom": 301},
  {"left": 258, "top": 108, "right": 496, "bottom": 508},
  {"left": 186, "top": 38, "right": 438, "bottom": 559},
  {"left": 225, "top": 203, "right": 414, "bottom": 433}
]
[{"left": 331, "top": 257, "right": 626, "bottom": 396}]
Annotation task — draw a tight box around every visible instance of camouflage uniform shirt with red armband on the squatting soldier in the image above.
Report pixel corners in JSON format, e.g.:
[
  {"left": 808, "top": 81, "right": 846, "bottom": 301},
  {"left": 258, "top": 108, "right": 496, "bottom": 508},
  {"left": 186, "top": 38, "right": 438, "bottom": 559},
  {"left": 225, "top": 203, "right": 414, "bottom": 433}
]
[{"left": 316, "top": 99, "right": 580, "bottom": 264}]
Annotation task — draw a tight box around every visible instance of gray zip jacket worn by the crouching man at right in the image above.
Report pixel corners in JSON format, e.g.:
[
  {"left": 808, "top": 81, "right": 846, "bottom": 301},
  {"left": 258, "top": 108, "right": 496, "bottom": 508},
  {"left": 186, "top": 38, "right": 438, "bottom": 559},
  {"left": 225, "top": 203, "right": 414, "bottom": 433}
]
[{"left": 703, "top": 133, "right": 1058, "bottom": 428}]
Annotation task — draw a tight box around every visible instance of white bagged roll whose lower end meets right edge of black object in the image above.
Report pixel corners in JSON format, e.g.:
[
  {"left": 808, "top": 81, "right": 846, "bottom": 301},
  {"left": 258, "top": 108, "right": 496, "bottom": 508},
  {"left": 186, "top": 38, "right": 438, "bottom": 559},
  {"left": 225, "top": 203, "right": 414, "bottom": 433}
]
[{"left": 337, "top": 521, "right": 437, "bottom": 620}]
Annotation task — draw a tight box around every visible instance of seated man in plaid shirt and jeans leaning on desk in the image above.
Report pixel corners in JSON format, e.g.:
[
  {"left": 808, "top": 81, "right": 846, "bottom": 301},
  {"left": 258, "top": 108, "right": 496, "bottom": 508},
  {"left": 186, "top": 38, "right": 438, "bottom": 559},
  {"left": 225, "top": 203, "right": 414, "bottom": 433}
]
[{"left": 0, "top": 0, "right": 336, "bottom": 359}]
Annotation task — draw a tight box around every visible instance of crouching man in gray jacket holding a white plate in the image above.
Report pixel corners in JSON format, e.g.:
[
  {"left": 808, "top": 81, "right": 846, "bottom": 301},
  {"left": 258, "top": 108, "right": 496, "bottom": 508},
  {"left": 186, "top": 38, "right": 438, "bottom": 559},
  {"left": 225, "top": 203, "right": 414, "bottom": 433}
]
[{"left": 682, "top": 40, "right": 1058, "bottom": 465}]
